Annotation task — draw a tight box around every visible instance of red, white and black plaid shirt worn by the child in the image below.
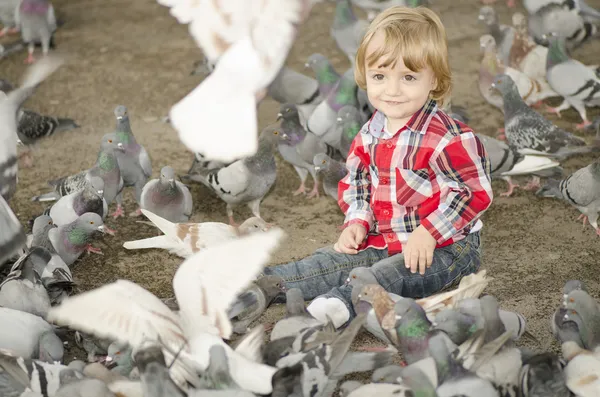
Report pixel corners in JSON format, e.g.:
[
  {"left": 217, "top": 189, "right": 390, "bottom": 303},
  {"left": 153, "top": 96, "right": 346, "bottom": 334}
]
[{"left": 338, "top": 100, "right": 493, "bottom": 254}]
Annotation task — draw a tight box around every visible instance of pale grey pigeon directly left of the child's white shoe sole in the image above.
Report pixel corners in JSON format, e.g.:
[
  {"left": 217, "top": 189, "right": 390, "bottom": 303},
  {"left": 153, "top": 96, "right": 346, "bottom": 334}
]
[{"left": 270, "top": 288, "right": 323, "bottom": 341}]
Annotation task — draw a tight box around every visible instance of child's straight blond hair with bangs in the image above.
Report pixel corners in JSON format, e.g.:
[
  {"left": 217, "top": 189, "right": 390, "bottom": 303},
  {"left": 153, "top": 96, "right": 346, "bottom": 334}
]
[{"left": 354, "top": 6, "right": 452, "bottom": 104}]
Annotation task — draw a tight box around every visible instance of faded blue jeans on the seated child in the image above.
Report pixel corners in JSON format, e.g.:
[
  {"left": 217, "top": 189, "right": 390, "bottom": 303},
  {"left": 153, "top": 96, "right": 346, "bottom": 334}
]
[{"left": 263, "top": 232, "right": 481, "bottom": 318}]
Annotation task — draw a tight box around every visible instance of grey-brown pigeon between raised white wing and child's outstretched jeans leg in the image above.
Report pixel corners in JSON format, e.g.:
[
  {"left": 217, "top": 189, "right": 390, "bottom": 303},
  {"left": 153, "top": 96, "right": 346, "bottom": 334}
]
[{"left": 231, "top": 276, "right": 286, "bottom": 334}]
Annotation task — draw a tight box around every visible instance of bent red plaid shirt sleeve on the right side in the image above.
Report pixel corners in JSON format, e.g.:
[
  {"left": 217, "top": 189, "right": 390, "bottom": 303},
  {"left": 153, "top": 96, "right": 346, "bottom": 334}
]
[{"left": 421, "top": 132, "right": 493, "bottom": 244}]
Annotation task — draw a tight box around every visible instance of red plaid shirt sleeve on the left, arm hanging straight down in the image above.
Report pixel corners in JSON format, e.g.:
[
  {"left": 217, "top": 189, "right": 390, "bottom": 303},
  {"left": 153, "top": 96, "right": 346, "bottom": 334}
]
[{"left": 338, "top": 133, "right": 373, "bottom": 232}]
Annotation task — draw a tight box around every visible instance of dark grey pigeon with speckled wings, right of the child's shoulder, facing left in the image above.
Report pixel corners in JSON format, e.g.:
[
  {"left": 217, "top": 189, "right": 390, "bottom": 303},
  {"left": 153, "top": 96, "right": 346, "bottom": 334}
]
[{"left": 492, "top": 75, "right": 595, "bottom": 159}]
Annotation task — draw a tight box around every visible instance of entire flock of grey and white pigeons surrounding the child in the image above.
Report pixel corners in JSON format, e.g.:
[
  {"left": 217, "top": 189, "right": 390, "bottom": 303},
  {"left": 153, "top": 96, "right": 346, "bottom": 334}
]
[{"left": 0, "top": 0, "right": 600, "bottom": 397}]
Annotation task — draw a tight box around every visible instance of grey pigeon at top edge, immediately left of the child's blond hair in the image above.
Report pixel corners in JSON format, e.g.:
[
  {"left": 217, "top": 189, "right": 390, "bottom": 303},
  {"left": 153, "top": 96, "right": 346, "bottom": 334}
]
[{"left": 330, "top": 0, "right": 369, "bottom": 65}]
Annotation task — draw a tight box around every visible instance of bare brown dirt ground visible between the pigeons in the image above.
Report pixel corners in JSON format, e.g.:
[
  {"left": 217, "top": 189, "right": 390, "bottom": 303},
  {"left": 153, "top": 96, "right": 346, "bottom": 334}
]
[{"left": 0, "top": 0, "right": 600, "bottom": 366}]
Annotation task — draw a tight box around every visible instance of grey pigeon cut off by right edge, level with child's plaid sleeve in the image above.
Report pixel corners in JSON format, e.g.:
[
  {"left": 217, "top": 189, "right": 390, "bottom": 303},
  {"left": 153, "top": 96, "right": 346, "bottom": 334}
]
[{"left": 536, "top": 159, "right": 600, "bottom": 235}]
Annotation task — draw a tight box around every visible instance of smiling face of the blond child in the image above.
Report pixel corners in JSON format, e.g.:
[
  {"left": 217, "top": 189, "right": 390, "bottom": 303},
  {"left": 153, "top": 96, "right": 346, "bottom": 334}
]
[{"left": 365, "top": 32, "right": 436, "bottom": 133}]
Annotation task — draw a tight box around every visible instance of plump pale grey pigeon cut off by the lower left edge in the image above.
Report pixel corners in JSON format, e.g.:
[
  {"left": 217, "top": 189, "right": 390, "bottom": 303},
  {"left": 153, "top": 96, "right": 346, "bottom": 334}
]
[{"left": 0, "top": 307, "right": 64, "bottom": 363}]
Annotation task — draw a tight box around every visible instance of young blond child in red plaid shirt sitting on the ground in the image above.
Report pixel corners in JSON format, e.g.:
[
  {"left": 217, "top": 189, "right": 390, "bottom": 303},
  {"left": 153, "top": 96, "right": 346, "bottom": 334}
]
[{"left": 264, "top": 7, "right": 492, "bottom": 327}]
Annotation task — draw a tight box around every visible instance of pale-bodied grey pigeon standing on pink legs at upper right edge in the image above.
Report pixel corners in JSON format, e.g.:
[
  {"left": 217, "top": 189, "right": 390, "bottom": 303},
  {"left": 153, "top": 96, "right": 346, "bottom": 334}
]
[{"left": 546, "top": 35, "right": 600, "bottom": 128}]
